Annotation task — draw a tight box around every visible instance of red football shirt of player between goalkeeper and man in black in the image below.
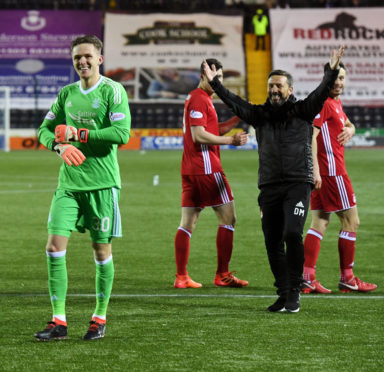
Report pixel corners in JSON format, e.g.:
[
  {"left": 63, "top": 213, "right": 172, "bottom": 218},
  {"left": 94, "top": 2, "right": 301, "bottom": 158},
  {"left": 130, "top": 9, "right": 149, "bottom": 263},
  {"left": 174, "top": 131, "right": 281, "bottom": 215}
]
[{"left": 181, "top": 88, "right": 222, "bottom": 175}]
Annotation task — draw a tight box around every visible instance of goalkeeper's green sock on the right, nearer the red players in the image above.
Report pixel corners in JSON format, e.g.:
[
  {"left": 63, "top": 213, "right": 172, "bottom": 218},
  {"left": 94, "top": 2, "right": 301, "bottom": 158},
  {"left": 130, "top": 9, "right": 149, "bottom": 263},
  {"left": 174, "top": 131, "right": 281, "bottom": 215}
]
[{"left": 94, "top": 255, "right": 115, "bottom": 317}]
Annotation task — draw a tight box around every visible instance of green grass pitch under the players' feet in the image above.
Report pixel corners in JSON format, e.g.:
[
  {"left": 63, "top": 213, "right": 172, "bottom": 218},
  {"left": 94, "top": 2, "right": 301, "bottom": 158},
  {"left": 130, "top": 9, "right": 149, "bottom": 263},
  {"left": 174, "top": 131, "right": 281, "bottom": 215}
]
[{"left": 0, "top": 149, "right": 384, "bottom": 372}]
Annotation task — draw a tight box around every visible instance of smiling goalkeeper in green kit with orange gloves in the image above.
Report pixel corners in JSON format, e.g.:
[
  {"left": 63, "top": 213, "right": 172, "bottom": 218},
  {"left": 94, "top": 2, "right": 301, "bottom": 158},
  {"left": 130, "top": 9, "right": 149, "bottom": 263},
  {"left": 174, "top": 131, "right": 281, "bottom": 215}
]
[{"left": 35, "top": 35, "right": 131, "bottom": 341}]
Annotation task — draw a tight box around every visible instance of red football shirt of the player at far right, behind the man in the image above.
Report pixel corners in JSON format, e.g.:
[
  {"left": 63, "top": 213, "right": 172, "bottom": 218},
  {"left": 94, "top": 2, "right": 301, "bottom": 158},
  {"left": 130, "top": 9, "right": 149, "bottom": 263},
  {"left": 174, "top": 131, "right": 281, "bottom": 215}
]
[{"left": 313, "top": 97, "right": 347, "bottom": 176}]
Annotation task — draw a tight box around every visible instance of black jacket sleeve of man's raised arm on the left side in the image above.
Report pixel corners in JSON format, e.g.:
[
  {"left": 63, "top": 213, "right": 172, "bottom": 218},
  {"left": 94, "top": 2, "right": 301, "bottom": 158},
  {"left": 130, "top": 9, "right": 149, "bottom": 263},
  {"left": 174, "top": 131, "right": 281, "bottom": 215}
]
[{"left": 210, "top": 76, "right": 257, "bottom": 125}]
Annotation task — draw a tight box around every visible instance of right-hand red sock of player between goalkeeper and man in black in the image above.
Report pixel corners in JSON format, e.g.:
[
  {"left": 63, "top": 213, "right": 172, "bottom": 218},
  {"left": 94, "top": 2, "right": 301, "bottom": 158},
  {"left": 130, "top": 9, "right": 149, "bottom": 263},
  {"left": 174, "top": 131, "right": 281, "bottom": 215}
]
[{"left": 216, "top": 225, "right": 235, "bottom": 274}]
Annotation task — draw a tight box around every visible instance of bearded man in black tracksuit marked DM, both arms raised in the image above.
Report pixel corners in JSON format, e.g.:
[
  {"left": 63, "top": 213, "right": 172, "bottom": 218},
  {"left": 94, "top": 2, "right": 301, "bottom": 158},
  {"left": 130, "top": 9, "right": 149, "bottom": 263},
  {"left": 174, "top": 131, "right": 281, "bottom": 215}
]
[{"left": 204, "top": 46, "right": 344, "bottom": 313}]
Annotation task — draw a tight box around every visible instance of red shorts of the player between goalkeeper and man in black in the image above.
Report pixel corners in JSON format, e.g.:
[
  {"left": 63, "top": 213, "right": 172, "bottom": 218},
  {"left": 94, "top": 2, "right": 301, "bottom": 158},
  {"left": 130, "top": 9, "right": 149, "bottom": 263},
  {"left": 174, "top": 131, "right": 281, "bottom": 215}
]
[{"left": 181, "top": 172, "right": 233, "bottom": 209}]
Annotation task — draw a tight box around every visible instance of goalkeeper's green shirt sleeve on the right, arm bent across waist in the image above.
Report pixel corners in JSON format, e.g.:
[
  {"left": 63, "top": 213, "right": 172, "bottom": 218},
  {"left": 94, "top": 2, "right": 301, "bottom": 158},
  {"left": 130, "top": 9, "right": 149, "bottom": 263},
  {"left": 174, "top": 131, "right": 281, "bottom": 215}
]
[{"left": 88, "top": 84, "right": 131, "bottom": 145}]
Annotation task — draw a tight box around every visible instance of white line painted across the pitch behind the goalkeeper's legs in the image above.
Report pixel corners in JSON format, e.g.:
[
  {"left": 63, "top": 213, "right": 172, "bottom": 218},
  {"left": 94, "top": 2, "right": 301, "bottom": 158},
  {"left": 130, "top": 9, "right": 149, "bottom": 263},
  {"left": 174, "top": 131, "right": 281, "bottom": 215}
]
[{"left": 0, "top": 293, "right": 384, "bottom": 300}]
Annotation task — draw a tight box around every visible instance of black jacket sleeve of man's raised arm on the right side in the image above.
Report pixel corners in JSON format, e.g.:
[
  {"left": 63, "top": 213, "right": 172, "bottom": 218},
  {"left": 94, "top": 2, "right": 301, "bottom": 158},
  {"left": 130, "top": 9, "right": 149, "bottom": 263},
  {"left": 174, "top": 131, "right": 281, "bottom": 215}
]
[{"left": 297, "top": 68, "right": 339, "bottom": 122}]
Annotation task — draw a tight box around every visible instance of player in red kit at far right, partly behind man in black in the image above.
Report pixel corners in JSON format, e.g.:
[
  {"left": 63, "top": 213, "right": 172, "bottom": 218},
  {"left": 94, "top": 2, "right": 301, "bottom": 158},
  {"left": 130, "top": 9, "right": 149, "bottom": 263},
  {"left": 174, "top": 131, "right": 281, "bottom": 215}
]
[{"left": 302, "top": 63, "right": 377, "bottom": 293}]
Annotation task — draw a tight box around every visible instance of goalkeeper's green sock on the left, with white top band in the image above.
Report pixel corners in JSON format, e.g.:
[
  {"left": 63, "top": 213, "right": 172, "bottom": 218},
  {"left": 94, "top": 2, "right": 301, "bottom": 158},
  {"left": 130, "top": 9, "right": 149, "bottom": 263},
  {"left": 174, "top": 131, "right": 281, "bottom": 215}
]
[{"left": 47, "top": 251, "right": 68, "bottom": 315}]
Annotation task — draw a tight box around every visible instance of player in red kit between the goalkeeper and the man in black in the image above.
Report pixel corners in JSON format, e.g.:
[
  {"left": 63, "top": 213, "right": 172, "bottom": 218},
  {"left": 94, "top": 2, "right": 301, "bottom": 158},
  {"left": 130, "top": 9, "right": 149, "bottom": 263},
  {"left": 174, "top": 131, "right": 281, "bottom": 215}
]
[{"left": 174, "top": 59, "right": 248, "bottom": 288}]
